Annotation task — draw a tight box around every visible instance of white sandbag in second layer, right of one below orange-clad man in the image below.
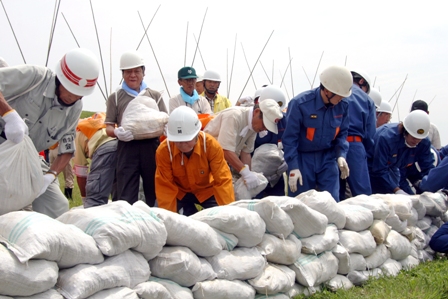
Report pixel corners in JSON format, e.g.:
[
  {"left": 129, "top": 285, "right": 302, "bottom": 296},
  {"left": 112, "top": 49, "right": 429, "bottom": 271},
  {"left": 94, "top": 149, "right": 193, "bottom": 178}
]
[{"left": 206, "top": 247, "right": 266, "bottom": 280}]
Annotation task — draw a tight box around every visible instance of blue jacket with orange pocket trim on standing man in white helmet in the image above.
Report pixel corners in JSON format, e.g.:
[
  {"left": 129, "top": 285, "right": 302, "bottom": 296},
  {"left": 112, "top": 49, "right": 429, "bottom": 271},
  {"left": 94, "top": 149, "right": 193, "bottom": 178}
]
[{"left": 282, "top": 87, "right": 349, "bottom": 169}]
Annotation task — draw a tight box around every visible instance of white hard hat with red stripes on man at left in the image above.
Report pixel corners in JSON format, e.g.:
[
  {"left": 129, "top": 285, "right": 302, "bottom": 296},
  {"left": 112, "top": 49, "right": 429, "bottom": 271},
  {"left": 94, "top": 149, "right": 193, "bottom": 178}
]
[{"left": 55, "top": 48, "right": 100, "bottom": 96}]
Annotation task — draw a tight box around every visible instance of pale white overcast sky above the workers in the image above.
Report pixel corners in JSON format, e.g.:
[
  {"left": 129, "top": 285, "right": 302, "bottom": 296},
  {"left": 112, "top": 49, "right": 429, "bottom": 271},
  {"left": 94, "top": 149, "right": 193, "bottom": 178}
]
[{"left": 0, "top": 0, "right": 448, "bottom": 145}]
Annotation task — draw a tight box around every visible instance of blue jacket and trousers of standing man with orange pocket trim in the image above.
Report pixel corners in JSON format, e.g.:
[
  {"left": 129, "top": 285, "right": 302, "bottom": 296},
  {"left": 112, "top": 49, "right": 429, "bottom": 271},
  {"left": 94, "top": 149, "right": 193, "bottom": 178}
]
[{"left": 282, "top": 87, "right": 349, "bottom": 201}]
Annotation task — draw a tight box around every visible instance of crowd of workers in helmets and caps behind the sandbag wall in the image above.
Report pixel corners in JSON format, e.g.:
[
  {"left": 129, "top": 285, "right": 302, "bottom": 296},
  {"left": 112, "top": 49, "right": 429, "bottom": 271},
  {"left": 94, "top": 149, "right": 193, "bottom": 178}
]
[{"left": 0, "top": 49, "right": 448, "bottom": 230}]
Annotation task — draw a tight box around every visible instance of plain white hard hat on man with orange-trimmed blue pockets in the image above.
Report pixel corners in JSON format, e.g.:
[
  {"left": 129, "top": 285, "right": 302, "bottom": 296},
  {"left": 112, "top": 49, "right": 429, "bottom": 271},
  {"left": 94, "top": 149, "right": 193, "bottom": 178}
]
[{"left": 319, "top": 65, "right": 353, "bottom": 97}]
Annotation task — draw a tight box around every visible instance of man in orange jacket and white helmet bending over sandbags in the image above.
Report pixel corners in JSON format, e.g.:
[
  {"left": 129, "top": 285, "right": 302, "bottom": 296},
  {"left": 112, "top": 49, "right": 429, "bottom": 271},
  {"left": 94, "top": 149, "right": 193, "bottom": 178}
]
[{"left": 155, "top": 106, "right": 235, "bottom": 216}]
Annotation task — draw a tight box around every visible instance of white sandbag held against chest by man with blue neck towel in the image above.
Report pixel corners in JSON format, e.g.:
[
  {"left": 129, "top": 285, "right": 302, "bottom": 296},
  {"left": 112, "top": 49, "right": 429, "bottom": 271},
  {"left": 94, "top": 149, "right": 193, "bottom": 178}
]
[{"left": 121, "top": 95, "right": 169, "bottom": 140}]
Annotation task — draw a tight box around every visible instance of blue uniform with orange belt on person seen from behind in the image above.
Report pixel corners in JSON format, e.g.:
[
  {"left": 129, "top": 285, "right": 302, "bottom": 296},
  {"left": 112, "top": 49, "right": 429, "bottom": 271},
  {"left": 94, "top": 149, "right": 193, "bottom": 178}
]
[{"left": 339, "top": 84, "right": 376, "bottom": 200}]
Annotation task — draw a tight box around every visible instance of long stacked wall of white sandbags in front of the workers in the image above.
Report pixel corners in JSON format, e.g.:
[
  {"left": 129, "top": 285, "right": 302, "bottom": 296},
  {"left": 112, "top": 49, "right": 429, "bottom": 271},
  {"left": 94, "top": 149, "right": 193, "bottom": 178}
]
[{"left": 0, "top": 190, "right": 448, "bottom": 299}]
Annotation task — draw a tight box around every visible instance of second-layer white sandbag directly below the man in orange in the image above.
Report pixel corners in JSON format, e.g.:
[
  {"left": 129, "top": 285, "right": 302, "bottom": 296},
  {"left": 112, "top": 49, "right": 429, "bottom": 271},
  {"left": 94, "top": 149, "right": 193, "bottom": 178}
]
[{"left": 149, "top": 246, "right": 216, "bottom": 287}]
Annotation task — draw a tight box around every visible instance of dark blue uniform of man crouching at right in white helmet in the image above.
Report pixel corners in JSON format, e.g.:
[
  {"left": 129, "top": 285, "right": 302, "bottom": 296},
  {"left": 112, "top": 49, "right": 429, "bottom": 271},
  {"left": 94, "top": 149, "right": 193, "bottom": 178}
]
[{"left": 367, "top": 123, "right": 434, "bottom": 193}]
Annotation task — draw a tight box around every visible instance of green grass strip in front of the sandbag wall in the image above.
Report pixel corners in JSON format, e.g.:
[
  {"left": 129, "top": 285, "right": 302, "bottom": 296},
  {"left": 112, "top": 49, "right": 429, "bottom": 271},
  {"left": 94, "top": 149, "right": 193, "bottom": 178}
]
[{"left": 294, "top": 257, "right": 448, "bottom": 299}]
